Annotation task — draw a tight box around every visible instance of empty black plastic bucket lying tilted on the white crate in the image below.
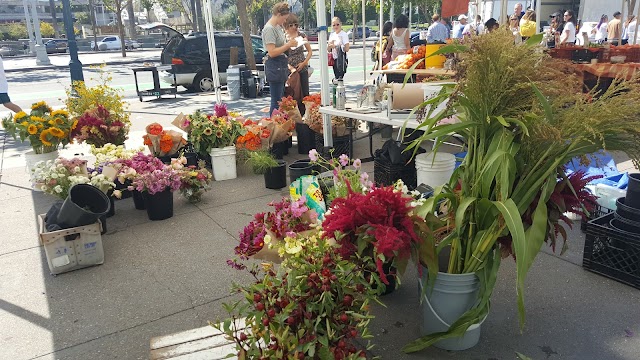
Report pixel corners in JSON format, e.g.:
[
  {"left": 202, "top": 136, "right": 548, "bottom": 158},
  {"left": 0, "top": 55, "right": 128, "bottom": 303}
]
[{"left": 58, "top": 184, "right": 111, "bottom": 229}]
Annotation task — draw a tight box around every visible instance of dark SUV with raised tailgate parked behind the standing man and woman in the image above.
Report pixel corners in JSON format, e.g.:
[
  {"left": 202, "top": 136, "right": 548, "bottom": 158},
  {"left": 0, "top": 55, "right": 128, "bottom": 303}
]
[{"left": 140, "top": 24, "right": 266, "bottom": 91}]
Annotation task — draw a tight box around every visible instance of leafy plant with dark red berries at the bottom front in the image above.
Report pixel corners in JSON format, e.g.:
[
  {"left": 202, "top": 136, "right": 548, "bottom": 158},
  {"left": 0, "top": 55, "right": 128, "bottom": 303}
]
[{"left": 213, "top": 235, "right": 376, "bottom": 359}]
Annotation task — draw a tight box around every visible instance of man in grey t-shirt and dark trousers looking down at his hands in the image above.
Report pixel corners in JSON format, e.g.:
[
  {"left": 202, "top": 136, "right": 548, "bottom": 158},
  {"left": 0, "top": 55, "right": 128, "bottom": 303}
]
[{"left": 262, "top": 2, "right": 298, "bottom": 116}]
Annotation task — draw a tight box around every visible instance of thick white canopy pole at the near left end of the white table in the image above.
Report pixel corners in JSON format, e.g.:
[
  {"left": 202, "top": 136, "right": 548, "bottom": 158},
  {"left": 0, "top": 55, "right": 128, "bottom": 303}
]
[{"left": 316, "top": 0, "right": 333, "bottom": 150}]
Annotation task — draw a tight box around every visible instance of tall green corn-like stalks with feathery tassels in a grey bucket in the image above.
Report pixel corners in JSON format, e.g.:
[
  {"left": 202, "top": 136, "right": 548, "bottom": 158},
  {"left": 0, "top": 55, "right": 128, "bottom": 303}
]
[{"left": 404, "top": 31, "right": 640, "bottom": 352}]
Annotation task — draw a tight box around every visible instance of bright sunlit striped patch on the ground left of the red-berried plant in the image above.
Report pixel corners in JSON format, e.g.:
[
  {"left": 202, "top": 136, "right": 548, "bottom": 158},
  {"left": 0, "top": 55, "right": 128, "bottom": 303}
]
[{"left": 149, "top": 319, "right": 244, "bottom": 360}]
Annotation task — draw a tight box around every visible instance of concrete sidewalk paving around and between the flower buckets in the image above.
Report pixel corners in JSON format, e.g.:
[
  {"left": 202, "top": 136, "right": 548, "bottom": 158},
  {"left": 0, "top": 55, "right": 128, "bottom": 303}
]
[{"left": 0, "top": 94, "right": 640, "bottom": 360}]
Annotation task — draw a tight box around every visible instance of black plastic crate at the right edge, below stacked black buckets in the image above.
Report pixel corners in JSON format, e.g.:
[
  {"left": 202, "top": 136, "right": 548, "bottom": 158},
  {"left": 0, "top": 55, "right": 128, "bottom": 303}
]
[{"left": 582, "top": 213, "right": 640, "bottom": 289}]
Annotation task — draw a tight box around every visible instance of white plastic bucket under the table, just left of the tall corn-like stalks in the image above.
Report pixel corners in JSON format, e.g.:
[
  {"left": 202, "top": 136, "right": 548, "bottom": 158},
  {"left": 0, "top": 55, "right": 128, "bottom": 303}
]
[{"left": 416, "top": 152, "right": 456, "bottom": 189}]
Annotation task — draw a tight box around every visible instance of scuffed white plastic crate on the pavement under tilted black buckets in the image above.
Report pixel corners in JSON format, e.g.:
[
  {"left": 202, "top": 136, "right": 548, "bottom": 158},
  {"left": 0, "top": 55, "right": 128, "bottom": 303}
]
[{"left": 38, "top": 214, "right": 104, "bottom": 275}]
